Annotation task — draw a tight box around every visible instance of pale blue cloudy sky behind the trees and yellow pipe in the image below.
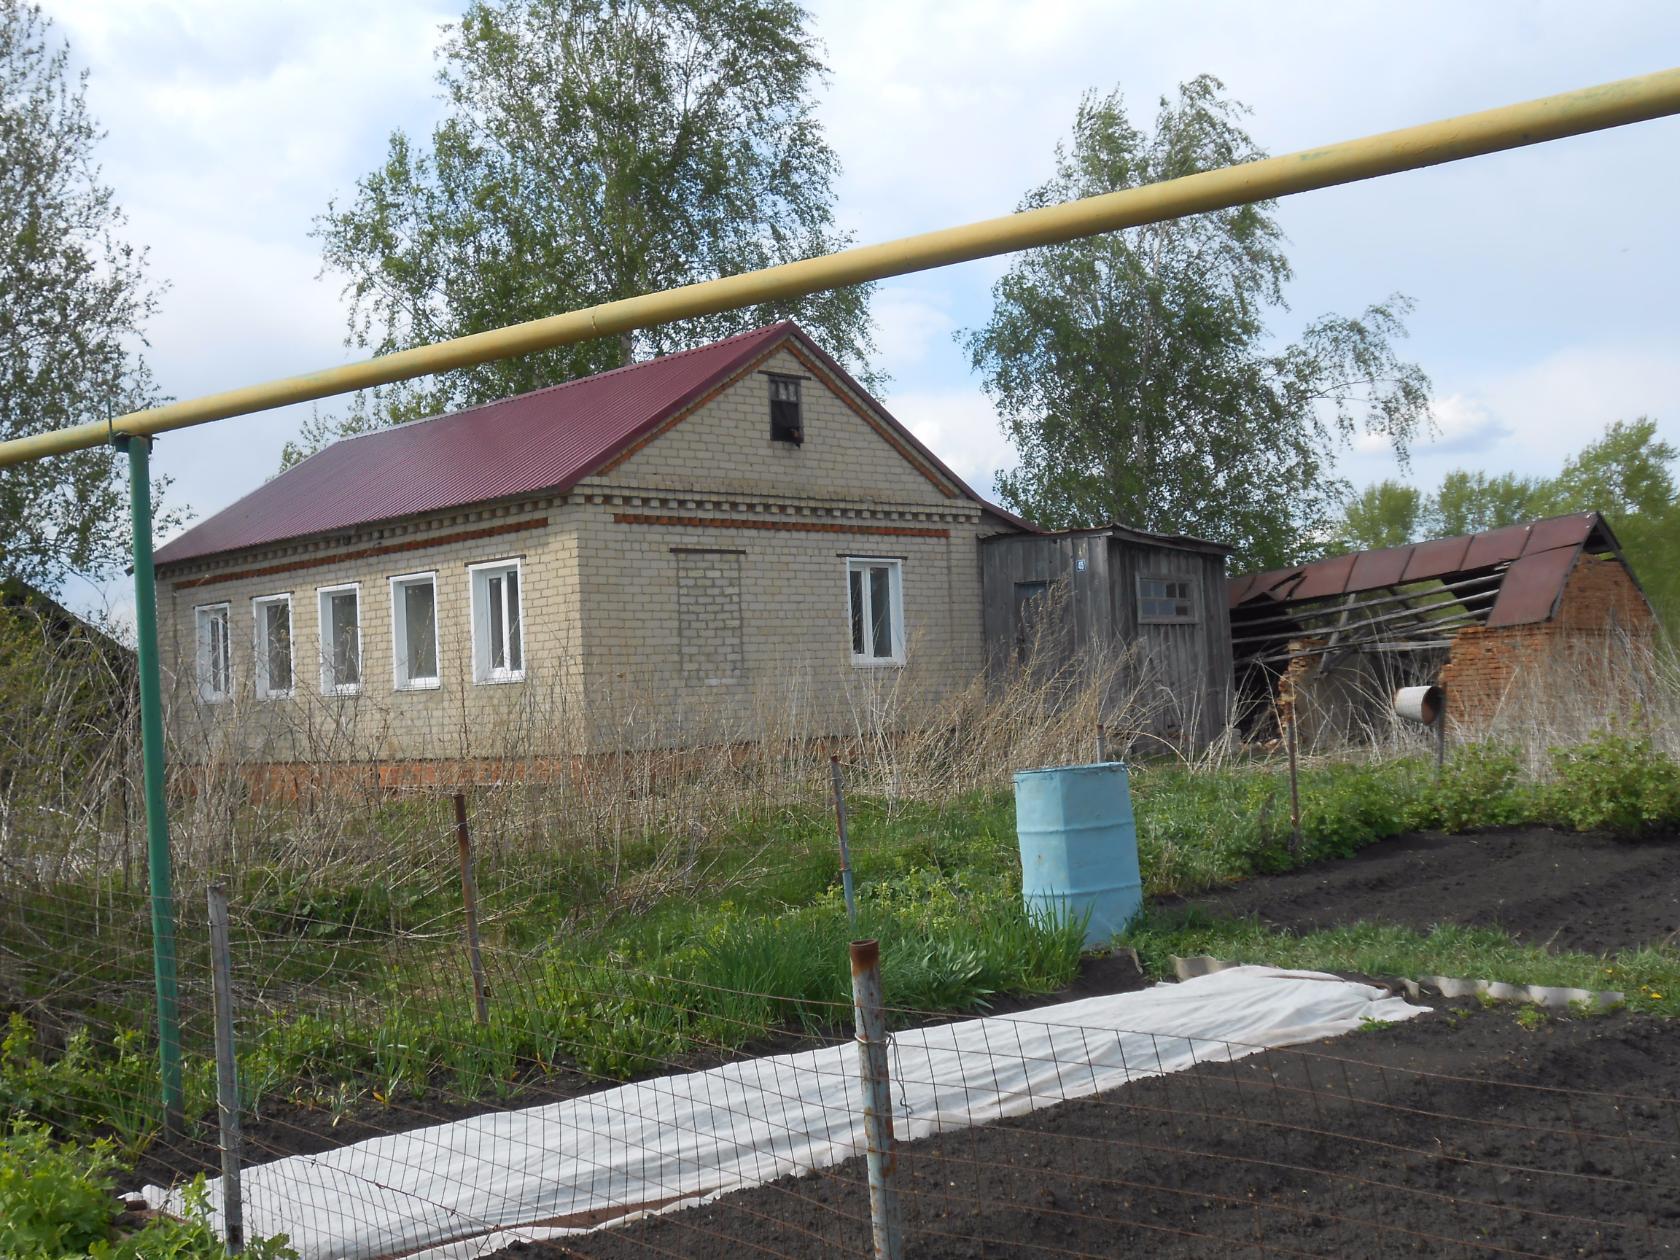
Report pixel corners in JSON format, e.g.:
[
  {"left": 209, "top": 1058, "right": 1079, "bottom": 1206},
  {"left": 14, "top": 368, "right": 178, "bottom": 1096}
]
[{"left": 44, "top": 0, "right": 1680, "bottom": 614}]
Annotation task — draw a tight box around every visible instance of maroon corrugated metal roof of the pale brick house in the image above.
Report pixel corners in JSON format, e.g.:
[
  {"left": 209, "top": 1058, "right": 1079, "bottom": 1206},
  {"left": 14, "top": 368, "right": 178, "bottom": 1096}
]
[{"left": 156, "top": 323, "right": 978, "bottom": 564}]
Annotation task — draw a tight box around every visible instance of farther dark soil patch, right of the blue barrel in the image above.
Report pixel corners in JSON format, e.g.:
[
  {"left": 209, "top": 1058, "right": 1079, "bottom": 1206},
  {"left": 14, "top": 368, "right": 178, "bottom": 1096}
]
[{"left": 1161, "top": 828, "right": 1680, "bottom": 953}]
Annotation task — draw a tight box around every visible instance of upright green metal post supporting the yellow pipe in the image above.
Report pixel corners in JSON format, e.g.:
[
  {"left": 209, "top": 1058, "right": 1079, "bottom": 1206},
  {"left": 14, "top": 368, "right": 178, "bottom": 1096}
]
[{"left": 113, "top": 433, "right": 185, "bottom": 1131}]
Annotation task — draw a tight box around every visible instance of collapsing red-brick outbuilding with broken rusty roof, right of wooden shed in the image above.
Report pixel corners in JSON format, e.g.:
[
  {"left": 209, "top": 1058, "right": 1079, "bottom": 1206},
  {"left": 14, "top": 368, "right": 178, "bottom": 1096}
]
[{"left": 1228, "top": 512, "right": 1656, "bottom": 746}]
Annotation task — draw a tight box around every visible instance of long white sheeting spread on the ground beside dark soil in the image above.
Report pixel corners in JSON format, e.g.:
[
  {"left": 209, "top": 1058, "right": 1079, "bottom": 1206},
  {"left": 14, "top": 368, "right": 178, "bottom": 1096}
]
[{"left": 143, "top": 966, "right": 1426, "bottom": 1260}]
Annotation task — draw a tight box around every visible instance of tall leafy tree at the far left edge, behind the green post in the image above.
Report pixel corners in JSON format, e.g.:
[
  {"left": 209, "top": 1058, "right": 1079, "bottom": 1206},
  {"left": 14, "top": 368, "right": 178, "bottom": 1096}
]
[{"left": 0, "top": 0, "right": 170, "bottom": 586}]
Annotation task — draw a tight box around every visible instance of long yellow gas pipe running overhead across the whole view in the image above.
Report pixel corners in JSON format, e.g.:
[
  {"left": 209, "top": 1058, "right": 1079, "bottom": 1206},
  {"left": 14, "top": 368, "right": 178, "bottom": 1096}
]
[{"left": 0, "top": 69, "right": 1680, "bottom": 467}]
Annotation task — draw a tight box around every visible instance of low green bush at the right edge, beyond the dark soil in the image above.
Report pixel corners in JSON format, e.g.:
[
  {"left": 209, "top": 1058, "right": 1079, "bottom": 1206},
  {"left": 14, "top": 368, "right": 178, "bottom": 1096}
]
[{"left": 1547, "top": 729, "right": 1680, "bottom": 837}]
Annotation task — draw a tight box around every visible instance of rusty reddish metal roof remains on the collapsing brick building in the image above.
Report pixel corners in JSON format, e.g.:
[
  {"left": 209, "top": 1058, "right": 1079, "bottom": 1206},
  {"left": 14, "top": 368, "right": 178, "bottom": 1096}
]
[{"left": 1228, "top": 512, "right": 1620, "bottom": 627}]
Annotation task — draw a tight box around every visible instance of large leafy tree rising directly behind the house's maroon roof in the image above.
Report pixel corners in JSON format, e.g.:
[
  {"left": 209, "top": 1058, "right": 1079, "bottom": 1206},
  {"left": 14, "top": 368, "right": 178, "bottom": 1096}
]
[{"left": 295, "top": 0, "right": 879, "bottom": 464}]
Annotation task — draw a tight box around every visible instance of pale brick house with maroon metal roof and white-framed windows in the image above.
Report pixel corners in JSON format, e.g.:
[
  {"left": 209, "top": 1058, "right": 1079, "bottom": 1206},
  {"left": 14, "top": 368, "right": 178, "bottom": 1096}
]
[{"left": 156, "top": 323, "right": 1028, "bottom": 774}]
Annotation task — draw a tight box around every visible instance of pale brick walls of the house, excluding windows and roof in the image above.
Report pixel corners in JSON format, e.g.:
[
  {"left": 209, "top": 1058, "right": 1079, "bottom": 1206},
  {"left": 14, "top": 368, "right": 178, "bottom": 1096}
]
[{"left": 160, "top": 341, "right": 991, "bottom": 761}]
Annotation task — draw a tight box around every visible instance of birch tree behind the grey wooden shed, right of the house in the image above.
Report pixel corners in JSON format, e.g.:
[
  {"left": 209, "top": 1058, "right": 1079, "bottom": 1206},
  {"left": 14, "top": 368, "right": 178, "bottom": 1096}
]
[{"left": 964, "top": 76, "right": 1430, "bottom": 566}]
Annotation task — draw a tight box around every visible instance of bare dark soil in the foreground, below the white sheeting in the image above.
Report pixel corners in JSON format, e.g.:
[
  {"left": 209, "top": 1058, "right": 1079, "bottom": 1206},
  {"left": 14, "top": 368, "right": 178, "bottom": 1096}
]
[{"left": 524, "top": 1006, "right": 1680, "bottom": 1260}]
